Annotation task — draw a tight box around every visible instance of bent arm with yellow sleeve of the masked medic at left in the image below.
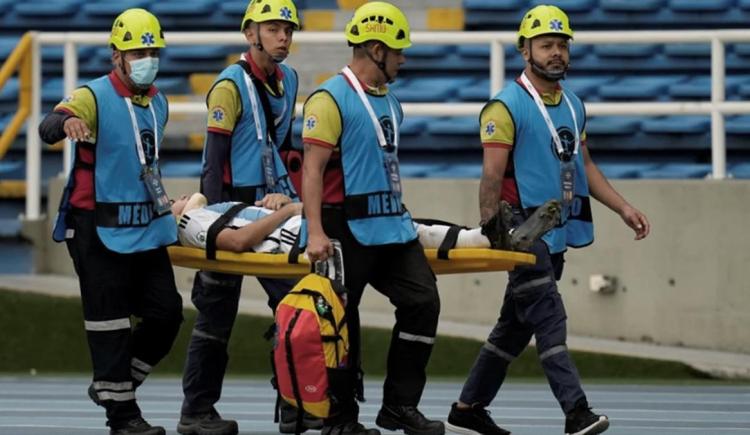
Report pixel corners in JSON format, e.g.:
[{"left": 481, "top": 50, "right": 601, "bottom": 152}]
[{"left": 39, "top": 88, "right": 96, "bottom": 144}]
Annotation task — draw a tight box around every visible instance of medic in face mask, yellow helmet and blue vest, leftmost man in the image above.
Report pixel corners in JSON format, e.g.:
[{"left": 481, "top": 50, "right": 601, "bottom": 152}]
[{"left": 39, "top": 9, "right": 182, "bottom": 435}]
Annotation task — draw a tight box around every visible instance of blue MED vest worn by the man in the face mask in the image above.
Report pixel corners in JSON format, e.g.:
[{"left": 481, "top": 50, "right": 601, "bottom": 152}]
[{"left": 53, "top": 76, "right": 177, "bottom": 253}]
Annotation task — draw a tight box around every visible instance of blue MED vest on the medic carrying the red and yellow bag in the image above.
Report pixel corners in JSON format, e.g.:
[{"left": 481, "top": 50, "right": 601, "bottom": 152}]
[{"left": 319, "top": 74, "right": 417, "bottom": 245}]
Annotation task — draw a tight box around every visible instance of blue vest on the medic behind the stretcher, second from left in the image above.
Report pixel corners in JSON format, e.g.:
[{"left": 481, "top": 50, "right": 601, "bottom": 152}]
[{"left": 209, "top": 64, "right": 297, "bottom": 202}]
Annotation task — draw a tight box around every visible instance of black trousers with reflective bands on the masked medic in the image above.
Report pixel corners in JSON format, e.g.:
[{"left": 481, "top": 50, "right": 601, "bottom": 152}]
[{"left": 66, "top": 210, "right": 182, "bottom": 428}]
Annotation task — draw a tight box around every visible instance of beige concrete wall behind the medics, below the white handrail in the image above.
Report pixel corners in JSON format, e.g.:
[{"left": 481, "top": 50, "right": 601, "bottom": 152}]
[{"left": 37, "top": 179, "right": 750, "bottom": 353}]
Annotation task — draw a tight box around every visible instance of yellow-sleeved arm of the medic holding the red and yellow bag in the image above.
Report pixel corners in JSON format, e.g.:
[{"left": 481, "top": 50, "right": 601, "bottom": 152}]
[{"left": 302, "top": 92, "right": 341, "bottom": 261}]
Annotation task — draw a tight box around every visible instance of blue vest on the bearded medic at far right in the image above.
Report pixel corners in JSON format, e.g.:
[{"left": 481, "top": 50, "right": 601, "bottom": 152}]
[{"left": 493, "top": 82, "right": 594, "bottom": 253}]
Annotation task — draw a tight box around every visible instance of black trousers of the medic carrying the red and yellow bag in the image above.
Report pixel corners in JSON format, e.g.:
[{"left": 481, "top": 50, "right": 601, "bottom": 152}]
[{"left": 322, "top": 207, "right": 440, "bottom": 425}]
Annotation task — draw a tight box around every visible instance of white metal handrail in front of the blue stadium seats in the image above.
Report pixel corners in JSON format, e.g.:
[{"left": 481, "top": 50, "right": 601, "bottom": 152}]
[{"left": 26, "top": 29, "right": 750, "bottom": 220}]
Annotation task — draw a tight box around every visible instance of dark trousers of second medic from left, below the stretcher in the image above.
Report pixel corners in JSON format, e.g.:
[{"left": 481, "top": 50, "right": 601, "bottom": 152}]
[{"left": 182, "top": 271, "right": 297, "bottom": 415}]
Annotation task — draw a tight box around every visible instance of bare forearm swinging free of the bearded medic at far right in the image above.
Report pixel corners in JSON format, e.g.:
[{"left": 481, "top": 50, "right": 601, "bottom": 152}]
[{"left": 581, "top": 146, "right": 651, "bottom": 240}]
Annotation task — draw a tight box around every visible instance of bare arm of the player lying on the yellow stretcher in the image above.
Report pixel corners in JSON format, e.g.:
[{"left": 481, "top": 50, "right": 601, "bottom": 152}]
[{"left": 216, "top": 202, "right": 302, "bottom": 252}]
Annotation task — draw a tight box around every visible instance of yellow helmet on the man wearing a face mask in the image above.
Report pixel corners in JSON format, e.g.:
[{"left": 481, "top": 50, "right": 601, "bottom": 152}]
[{"left": 109, "top": 8, "right": 167, "bottom": 51}]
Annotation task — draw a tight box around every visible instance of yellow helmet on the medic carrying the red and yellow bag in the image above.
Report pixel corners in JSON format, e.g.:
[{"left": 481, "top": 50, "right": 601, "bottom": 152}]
[{"left": 345, "top": 2, "right": 411, "bottom": 50}]
